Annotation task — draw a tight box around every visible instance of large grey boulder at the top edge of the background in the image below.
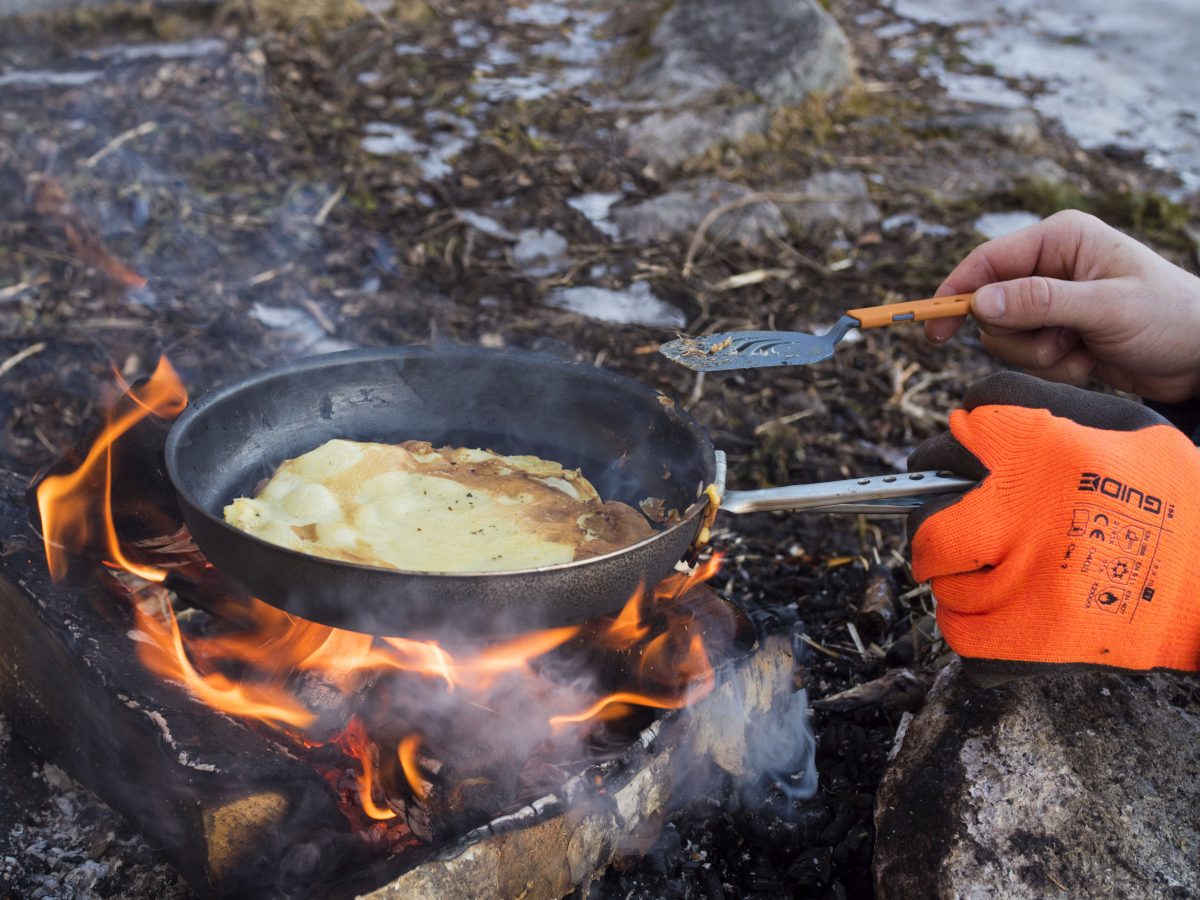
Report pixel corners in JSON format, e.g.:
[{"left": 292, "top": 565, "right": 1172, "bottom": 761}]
[{"left": 638, "top": 0, "right": 853, "bottom": 106}]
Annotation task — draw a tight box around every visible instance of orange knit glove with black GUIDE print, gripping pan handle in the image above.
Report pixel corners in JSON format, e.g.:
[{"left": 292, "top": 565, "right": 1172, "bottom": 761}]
[{"left": 908, "top": 372, "right": 1200, "bottom": 680}]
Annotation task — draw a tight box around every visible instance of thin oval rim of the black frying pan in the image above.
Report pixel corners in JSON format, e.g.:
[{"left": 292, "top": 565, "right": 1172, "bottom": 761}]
[{"left": 163, "top": 344, "right": 716, "bottom": 580}]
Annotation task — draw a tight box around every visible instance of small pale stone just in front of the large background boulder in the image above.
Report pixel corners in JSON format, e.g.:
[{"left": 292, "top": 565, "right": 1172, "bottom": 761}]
[{"left": 629, "top": 106, "right": 770, "bottom": 169}]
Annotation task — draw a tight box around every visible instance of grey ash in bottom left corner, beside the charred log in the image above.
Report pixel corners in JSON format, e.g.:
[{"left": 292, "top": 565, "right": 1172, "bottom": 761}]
[{"left": 0, "top": 716, "right": 191, "bottom": 900}]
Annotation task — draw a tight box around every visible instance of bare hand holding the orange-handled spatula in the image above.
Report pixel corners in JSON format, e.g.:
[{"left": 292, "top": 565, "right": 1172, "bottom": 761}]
[{"left": 925, "top": 210, "right": 1200, "bottom": 402}]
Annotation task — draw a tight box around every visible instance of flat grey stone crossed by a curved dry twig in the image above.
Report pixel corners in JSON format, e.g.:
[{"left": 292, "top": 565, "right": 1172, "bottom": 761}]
[{"left": 611, "top": 178, "right": 787, "bottom": 247}]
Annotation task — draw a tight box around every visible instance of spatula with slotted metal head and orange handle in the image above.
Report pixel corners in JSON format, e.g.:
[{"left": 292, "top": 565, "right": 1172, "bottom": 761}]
[{"left": 659, "top": 294, "right": 974, "bottom": 372}]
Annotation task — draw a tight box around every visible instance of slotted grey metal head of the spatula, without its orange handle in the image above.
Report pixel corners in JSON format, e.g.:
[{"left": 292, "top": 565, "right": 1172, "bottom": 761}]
[{"left": 659, "top": 316, "right": 858, "bottom": 372}]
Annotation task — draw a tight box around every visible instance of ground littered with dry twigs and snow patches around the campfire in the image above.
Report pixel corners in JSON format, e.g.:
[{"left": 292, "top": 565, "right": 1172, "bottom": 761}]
[{"left": 0, "top": 0, "right": 1200, "bottom": 898}]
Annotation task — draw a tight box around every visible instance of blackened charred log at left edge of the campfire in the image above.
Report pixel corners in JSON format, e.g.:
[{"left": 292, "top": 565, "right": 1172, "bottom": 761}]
[{"left": 0, "top": 473, "right": 354, "bottom": 896}]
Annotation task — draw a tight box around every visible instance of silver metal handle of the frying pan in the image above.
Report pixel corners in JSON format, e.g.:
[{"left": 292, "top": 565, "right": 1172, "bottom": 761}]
[{"left": 721, "top": 472, "right": 978, "bottom": 515}]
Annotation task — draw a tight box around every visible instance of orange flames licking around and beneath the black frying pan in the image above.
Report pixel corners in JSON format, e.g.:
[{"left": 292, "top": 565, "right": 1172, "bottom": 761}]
[{"left": 37, "top": 359, "right": 721, "bottom": 828}]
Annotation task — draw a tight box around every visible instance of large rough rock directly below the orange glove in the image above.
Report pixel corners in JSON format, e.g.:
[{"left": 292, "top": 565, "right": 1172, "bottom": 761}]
[{"left": 874, "top": 664, "right": 1200, "bottom": 900}]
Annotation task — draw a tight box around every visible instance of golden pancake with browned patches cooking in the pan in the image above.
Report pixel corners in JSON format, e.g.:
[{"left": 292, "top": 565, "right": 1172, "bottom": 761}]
[{"left": 224, "top": 440, "right": 653, "bottom": 572}]
